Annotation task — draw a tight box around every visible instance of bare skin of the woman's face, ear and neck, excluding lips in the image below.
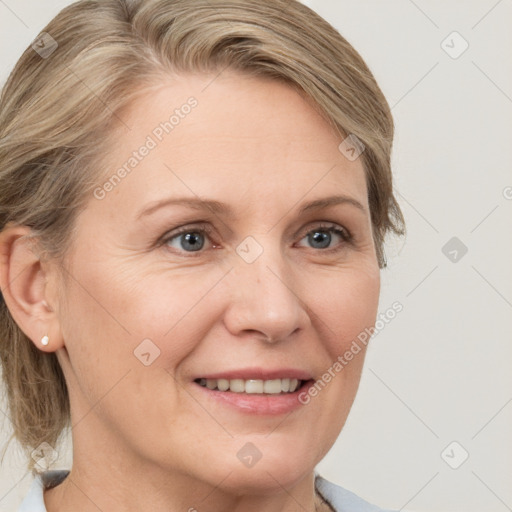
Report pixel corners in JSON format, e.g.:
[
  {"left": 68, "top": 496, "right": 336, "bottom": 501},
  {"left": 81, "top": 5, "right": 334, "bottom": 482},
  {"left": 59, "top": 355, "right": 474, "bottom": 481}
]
[{"left": 2, "top": 71, "right": 380, "bottom": 512}]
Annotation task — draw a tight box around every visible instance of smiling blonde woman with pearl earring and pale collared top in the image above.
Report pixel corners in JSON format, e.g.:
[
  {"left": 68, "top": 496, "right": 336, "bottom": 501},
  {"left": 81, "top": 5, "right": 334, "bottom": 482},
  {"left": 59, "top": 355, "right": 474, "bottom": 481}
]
[{"left": 0, "top": 0, "right": 403, "bottom": 512}]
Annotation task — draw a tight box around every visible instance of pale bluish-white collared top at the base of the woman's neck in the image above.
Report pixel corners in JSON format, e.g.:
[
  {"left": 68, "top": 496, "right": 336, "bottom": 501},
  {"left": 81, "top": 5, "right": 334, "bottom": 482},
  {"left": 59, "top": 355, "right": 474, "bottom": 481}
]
[{"left": 18, "top": 470, "right": 391, "bottom": 512}]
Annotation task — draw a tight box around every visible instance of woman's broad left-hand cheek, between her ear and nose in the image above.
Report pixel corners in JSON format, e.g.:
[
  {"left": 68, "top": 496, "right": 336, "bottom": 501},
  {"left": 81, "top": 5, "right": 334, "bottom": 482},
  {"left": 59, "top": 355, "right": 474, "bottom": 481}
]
[{"left": 62, "top": 256, "right": 226, "bottom": 370}]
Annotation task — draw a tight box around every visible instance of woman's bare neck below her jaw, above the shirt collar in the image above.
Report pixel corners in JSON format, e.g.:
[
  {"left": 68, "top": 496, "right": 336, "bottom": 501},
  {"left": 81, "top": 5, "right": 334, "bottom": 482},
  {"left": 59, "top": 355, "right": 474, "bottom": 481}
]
[{"left": 44, "top": 411, "right": 329, "bottom": 512}]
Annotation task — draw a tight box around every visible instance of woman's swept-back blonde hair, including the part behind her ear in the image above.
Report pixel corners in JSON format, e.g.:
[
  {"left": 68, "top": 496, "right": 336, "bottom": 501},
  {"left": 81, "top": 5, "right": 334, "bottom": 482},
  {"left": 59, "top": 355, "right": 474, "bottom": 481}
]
[{"left": 0, "top": 0, "right": 404, "bottom": 467}]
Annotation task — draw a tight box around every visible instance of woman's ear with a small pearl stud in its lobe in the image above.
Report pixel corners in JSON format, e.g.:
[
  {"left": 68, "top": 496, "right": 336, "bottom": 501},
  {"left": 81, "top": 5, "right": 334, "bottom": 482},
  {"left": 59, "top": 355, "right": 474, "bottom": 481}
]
[{"left": 0, "top": 224, "right": 64, "bottom": 352}]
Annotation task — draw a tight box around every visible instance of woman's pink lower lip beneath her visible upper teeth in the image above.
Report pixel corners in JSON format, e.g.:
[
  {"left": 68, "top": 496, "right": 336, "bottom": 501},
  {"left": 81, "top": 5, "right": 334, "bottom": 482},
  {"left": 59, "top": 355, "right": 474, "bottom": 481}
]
[{"left": 194, "top": 380, "right": 314, "bottom": 416}]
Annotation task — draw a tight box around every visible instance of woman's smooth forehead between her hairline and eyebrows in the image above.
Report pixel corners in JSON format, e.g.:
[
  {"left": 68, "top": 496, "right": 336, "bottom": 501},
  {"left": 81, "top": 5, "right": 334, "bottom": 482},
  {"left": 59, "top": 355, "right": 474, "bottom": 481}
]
[{"left": 92, "top": 72, "right": 367, "bottom": 216}]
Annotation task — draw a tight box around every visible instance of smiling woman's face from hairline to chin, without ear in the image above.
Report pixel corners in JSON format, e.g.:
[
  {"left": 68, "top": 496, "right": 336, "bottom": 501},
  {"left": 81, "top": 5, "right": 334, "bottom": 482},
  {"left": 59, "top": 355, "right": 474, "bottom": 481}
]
[{"left": 52, "top": 72, "right": 379, "bottom": 492}]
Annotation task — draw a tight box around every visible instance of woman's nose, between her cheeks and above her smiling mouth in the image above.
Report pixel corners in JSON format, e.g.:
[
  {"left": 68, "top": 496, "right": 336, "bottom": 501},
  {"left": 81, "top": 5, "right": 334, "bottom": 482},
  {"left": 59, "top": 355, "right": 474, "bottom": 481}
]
[{"left": 224, "top": 244, "right": 310, "bottom": 343}]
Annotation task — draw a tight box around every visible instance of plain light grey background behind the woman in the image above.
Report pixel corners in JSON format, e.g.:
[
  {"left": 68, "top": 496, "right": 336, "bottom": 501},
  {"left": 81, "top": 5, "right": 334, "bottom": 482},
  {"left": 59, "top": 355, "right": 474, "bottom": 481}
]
[{"left": 0, "top": 0, "right": 512, "bottom": 512}]
